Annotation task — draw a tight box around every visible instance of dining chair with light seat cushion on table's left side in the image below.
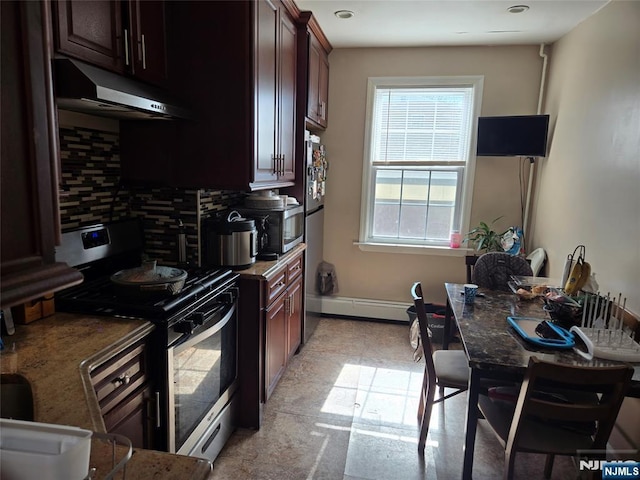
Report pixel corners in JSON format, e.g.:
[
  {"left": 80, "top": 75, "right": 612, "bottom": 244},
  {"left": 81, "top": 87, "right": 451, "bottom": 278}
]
[{"left": 411, "top": 282, "right": 469, "bottom": 453}]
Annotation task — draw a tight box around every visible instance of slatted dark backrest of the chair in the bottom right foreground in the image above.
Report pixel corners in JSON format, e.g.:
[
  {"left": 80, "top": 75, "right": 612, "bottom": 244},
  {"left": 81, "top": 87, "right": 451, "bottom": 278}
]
[{"left": 507, "top": 357, "right": 633, "bottom": 449}]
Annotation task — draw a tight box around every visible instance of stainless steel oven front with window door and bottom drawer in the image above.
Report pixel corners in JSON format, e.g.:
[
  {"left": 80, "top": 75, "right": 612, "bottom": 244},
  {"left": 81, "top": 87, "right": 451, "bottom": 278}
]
[{"left": 167, "top": 288, "right": 238, "bottom": 460}]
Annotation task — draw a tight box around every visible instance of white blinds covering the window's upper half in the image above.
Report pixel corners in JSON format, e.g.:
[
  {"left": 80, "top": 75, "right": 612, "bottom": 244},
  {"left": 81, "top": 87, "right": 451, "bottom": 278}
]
[{"left": 371, "top": 86, "right": 473, "bottom": 166}]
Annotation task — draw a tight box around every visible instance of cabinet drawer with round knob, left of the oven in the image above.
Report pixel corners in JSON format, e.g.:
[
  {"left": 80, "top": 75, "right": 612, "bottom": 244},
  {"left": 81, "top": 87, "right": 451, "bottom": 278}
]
[{"left": 91, "top": 342, "right": 147, "bottom": 414}]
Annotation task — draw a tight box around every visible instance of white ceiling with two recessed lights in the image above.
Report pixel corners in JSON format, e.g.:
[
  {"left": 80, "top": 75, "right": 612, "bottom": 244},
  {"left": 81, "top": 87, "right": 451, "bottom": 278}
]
[{"left": 296, "top": 0, "right": 610, "bottom": 48}]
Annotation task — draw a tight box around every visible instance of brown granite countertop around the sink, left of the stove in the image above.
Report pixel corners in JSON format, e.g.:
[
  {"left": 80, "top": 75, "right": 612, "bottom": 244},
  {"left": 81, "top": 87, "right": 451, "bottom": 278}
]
[{"left": 0, "top": 313, "right": 212, "bottom": 480}]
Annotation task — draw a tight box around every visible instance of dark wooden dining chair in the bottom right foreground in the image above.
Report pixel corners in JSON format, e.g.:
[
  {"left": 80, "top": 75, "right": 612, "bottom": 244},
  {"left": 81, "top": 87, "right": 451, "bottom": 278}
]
[{"left": 478, "top": 357, "right": 633, "bottom": 480}]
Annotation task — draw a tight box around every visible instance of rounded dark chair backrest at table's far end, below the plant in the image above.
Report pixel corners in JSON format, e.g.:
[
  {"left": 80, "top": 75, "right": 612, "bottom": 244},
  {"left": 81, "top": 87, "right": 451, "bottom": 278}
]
[{"left": 472, "top": 252, "right": 533, "bottom": 292}]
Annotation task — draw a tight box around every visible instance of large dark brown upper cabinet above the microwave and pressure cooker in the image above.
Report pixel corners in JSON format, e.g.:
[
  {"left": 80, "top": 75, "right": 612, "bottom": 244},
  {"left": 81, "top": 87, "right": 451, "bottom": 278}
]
[{"left": 121, "top": 0, "right": 299, "bottom": 191}]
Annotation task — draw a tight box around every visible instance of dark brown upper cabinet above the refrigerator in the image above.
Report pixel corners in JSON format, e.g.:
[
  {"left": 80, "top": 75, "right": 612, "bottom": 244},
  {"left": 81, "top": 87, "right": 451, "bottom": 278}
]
[{"left": 300, "top": 12, "right": 332, "bottom": 129}]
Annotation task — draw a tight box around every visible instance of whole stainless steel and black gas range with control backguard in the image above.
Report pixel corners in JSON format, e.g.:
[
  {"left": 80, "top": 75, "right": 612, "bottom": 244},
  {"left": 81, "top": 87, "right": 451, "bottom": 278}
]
[{"left": 56, "top": 220, "right": 239, "bottom": 461}]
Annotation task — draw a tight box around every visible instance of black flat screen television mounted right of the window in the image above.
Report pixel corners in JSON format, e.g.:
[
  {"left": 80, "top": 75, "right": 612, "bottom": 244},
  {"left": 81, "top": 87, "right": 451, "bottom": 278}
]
[{"left": 476, "top": 115, "right": 549, "bottom": 157}]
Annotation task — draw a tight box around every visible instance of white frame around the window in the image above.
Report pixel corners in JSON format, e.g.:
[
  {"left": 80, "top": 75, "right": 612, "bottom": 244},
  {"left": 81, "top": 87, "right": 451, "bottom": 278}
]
[{"left": 354, "top": 75, "right": 484, "bottom": 255}]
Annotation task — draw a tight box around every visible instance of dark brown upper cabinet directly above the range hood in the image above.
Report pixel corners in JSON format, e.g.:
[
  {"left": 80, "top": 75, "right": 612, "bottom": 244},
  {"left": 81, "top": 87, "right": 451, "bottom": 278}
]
[{"left": 53, "top": 0, "right": 167, "bottom": 85}]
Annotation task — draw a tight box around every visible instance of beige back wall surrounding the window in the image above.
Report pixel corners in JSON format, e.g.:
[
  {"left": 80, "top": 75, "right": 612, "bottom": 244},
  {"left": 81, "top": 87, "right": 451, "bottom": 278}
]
[{"left": 322, "top": 46, "right": 542, "bottom": 303}]
